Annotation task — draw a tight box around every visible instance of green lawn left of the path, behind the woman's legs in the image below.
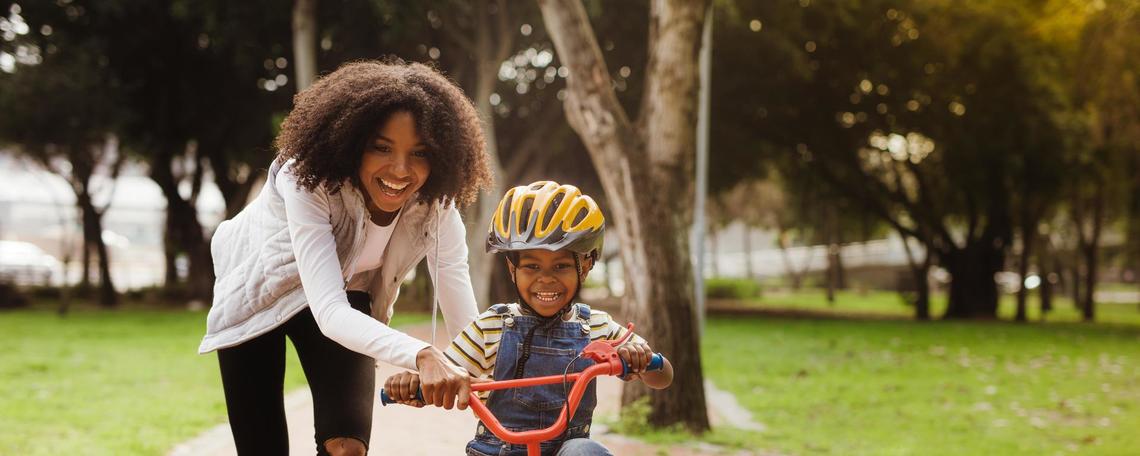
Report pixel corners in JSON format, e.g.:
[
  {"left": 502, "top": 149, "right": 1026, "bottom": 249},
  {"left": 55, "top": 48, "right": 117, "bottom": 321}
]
[{"left": 0, "top": 308, "right": 430, "bottom": 455}]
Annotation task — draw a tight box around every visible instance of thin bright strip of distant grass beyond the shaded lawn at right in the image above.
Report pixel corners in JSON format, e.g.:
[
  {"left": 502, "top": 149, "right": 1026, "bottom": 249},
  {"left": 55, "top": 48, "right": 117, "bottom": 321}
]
[{"left": 736, "top": 288, "right": 1140, "bottom": 325}]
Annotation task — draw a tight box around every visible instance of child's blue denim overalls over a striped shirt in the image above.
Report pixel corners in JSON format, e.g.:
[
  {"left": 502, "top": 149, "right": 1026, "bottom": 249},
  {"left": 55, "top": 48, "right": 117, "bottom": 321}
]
[{"left": 467, "top": 304, "right": 597, "bottom": 456}]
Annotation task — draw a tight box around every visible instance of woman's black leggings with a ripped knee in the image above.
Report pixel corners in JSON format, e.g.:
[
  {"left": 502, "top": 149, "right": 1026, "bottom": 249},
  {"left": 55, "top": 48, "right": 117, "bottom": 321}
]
[{"left": 218, "top": 291, "right": 376, "bottom": 455}]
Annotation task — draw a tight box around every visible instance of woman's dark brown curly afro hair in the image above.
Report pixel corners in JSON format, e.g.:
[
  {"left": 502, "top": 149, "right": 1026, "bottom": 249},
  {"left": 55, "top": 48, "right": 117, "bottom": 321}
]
[{"left": 275, "top": 59, "right": 491, "bottom": 205}]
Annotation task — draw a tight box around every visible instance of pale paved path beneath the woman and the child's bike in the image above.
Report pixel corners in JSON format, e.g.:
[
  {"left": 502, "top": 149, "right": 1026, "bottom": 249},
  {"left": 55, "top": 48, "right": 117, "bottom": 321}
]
[{"left": 170, "top": 325, "right": 763, "bottom": 456}]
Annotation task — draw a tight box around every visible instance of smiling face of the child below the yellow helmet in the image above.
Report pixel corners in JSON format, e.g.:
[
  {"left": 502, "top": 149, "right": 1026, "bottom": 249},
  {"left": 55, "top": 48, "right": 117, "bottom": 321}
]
[{"left": 507, "top": 249, "right": 594, "bottom": 317}]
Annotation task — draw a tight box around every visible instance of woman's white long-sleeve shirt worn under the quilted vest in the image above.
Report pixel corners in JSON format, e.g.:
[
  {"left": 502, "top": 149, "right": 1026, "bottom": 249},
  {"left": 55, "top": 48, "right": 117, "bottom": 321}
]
[{"left": 276, "top": 163, "right": 478, "bottom": 369}]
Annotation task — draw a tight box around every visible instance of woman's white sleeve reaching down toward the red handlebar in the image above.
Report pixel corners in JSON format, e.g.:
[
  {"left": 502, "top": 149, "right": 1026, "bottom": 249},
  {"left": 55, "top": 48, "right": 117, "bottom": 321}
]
[{"left": 276, "top": 165, "right": 428, "bottom": 369}]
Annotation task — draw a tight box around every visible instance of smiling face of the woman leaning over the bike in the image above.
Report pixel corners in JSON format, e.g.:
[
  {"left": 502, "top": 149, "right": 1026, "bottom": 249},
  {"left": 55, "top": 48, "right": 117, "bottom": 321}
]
[{"left": 359, "top": 111, "right": 431, "bottom": 213}]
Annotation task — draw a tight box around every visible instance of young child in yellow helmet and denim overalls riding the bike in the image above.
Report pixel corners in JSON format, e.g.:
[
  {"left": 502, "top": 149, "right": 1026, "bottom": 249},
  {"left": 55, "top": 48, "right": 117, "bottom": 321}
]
[{"left": 384, "top": 181, "right": 673, "bottom": 456}]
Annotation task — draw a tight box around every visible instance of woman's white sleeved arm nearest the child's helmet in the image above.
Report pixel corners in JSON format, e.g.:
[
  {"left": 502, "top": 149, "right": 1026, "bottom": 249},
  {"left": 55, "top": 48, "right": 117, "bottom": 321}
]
[{"left": 428, "top": 205, "right": 479, "bottom": 339}]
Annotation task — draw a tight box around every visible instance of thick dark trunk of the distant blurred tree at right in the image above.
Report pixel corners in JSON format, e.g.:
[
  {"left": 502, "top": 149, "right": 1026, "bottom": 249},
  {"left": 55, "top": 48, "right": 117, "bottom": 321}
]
[{"left": 942, "top": 237, "right": 1004, "bottom": 319}]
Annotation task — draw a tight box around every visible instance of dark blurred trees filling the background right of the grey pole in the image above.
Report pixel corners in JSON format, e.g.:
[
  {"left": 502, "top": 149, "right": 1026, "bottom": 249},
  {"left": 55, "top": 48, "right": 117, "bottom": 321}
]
[{"left": 711, "top": 0, "right": 1140, "bottom": 320}]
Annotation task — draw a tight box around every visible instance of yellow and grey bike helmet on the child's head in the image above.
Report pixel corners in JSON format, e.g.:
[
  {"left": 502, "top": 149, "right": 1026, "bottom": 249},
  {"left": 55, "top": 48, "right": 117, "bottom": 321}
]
[{"left": 487, "top": 180, "right": 605, "bottom": 259}]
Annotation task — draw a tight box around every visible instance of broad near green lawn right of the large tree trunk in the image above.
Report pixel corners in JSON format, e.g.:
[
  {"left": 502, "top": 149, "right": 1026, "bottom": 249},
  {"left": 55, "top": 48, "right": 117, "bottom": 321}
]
[{"left": 702, "top": 317, "right": 1140, "bottom": 455}]
